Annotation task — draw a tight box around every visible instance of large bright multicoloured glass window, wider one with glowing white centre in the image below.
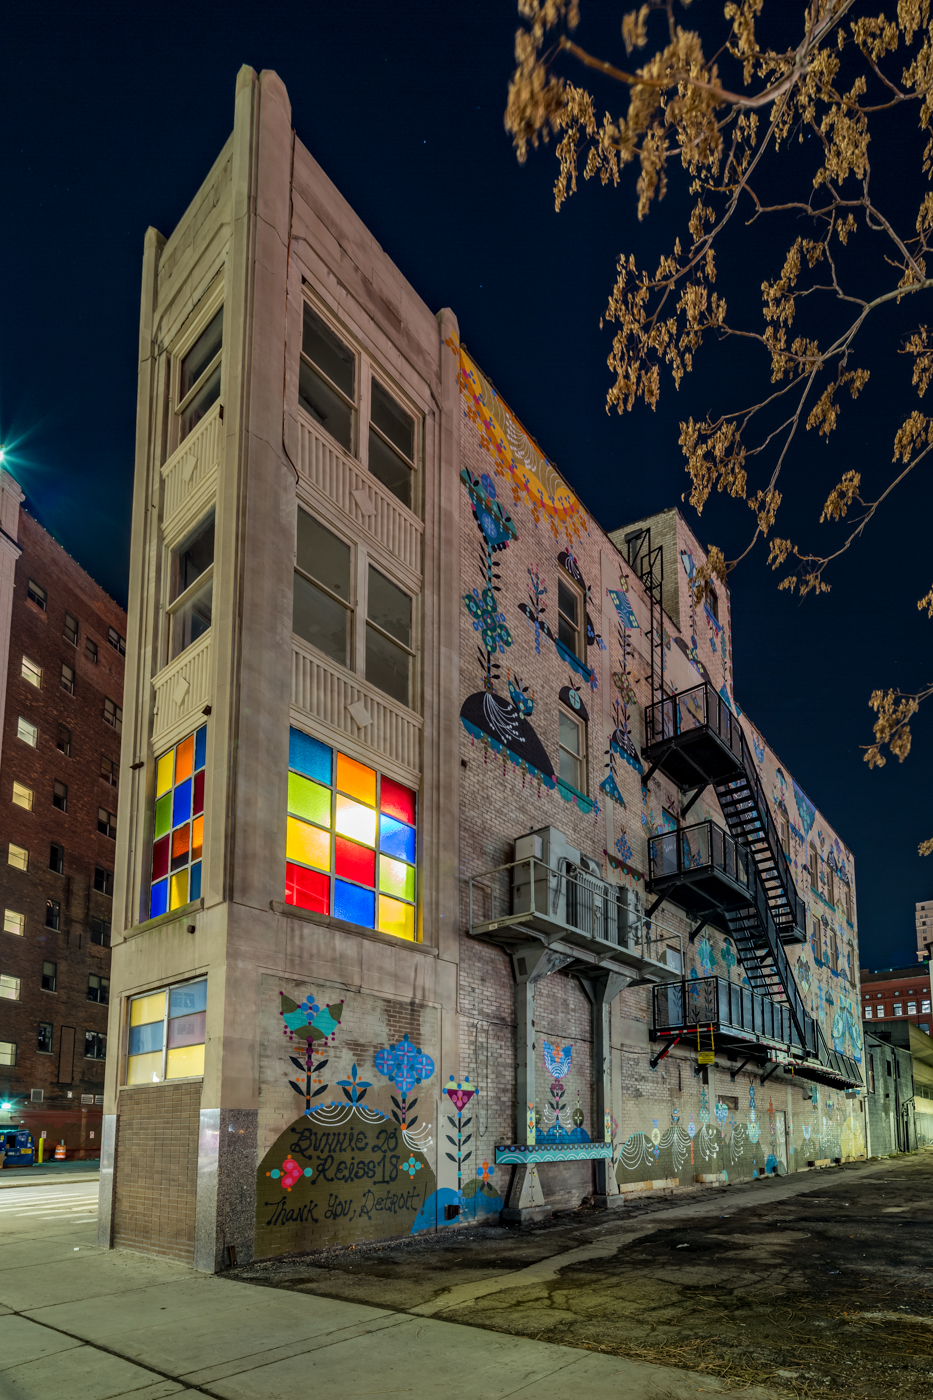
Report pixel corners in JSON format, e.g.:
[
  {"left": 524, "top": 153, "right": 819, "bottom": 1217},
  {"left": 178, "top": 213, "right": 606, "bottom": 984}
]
[{"left": 286, "top": 729, "right": 416, "bottom": 942}]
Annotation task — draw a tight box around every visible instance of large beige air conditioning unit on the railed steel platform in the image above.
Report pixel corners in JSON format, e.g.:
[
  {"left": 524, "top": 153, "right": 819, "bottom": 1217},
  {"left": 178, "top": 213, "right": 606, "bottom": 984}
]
[{"left": 511, "top": 826, "right": 642, "bottom": 946}]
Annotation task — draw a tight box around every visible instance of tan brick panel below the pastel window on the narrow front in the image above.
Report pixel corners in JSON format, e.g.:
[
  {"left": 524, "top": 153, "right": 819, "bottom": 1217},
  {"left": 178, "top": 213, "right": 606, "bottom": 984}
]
[{"left": 113, "top": 1082, "right": 200, "bottom": 1264}]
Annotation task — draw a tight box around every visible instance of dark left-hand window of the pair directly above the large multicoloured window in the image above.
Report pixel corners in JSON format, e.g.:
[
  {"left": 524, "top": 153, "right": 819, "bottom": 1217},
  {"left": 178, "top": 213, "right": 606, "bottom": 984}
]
[{"left": 291, "top": 510, "right": 353, "bottom": 666}]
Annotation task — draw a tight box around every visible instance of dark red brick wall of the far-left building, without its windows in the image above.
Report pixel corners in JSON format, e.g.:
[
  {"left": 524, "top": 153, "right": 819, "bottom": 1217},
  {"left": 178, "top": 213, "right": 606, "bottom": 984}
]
[{"left": 0, "top": 511, "right": 126, "bottom": 1147}]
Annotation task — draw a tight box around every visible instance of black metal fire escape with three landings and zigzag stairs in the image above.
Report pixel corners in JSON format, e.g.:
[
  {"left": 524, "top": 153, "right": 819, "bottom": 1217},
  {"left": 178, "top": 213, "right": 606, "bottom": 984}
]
[{"left": 643, "top": 683, "right": 862, "bottom": 1086}]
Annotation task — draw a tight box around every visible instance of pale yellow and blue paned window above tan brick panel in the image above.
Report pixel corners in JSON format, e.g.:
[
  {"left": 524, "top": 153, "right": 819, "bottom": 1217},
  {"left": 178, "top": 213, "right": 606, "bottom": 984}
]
[{"left": 125, "top": 979, "right": 207, "bottom": 1084}]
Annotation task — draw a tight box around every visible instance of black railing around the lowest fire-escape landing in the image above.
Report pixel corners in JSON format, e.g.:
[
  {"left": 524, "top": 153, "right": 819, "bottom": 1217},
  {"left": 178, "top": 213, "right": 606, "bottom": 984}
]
[{"left": 651, "top": 977, "right": 808, "bottom": 1050}]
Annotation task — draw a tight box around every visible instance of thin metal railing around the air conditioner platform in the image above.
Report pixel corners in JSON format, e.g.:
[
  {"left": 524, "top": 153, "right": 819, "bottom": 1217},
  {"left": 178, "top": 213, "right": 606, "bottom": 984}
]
[{"left": 468, "top": 857, "right": 651, "bottom": 958}]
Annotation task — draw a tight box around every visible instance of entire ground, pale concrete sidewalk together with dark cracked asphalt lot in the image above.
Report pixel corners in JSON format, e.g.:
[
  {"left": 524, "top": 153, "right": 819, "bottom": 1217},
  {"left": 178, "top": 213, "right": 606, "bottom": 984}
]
[{"left": 0, "top": 1151, "right": 933, "bottom": 1400}]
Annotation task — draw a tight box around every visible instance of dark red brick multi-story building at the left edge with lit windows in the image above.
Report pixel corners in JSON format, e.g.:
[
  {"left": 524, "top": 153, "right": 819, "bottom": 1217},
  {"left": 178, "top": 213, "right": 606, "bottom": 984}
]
[{"left": 0, "top": 472, "right": 126, "bottom": 1156}]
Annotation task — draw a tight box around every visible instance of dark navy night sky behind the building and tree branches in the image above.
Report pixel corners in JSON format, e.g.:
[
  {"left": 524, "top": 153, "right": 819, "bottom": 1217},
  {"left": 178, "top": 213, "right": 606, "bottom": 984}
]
[{"left": 0, "top": 0, "right": 933, "bottom": 967}]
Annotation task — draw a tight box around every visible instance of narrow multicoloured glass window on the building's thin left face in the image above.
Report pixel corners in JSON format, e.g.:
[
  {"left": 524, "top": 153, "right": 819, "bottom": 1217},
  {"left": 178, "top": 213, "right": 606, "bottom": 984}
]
[{"left": 148, "top": 725, "right": 207, "bottom": 918}]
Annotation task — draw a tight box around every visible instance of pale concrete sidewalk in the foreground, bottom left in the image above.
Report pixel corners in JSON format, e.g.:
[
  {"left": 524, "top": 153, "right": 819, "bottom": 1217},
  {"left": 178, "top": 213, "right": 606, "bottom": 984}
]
[{"left": 0, "top": 1209, "right": 775, "bottom": 1400}]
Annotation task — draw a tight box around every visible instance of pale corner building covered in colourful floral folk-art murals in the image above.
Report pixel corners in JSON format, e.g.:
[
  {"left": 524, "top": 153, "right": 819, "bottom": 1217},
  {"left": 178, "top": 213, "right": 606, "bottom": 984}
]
[{"left": 101, "top": 69, "right": 864, "bottom": 1270}]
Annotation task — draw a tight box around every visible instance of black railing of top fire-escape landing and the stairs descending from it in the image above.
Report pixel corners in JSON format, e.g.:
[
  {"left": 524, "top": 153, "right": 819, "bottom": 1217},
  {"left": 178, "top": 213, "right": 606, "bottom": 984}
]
[{"left": 644, "top": 682, "right": 807, "bottom": 931}]
